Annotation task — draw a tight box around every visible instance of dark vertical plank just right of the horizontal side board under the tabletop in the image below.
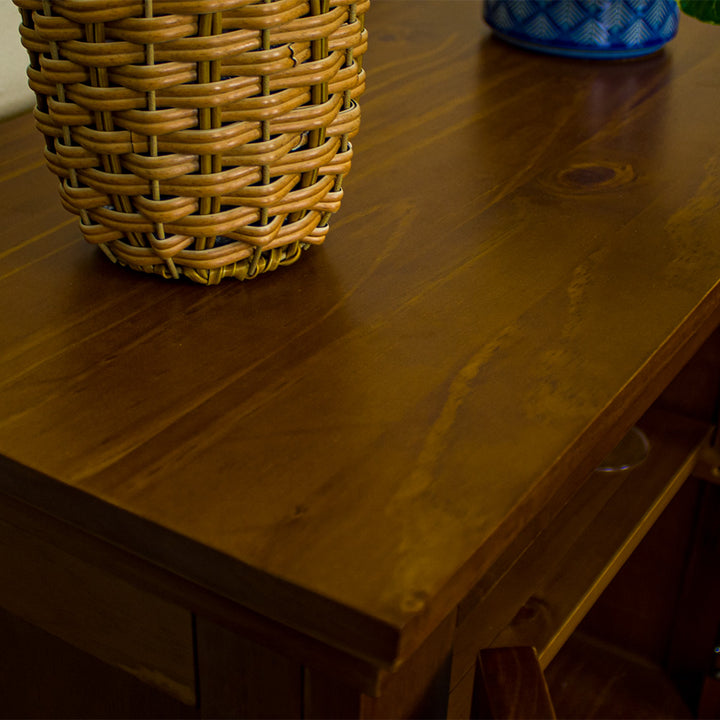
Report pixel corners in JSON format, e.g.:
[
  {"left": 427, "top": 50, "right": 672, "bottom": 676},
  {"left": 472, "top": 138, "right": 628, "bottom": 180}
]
[{"left": 196, "top": 616, "right": 303, "bottom": 720}]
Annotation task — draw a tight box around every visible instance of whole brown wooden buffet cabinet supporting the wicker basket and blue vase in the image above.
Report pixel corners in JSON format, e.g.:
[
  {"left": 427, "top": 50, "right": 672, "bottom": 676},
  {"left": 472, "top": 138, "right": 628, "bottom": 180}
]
[{"left": 0, "top": 0, "right": 720, "bottom": 718}]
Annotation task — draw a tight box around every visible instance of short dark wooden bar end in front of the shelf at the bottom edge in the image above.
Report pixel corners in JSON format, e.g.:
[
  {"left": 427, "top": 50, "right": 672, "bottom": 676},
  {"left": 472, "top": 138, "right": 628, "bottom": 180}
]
[{"left": 471, "top": 647, "right": 555, "bottom": 720}]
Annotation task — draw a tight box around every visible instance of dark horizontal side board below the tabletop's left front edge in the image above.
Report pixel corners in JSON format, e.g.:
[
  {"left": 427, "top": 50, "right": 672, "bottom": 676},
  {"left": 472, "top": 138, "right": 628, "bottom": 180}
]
[{"left": 0, "top": 502, "right": 196, "bottom": 705}]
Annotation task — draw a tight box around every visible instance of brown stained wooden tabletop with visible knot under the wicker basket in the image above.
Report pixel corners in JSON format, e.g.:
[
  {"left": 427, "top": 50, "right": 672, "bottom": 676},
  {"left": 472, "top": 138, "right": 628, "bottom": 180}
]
[{"left": 0, "top": 0, "right": 720, "bottom": 666}]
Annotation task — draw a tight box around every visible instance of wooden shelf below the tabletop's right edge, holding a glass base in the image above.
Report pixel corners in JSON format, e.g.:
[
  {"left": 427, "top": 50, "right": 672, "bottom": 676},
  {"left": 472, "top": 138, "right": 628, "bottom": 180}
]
[{"left": 449, "top": 408, "right": 710, "bottom": 717}]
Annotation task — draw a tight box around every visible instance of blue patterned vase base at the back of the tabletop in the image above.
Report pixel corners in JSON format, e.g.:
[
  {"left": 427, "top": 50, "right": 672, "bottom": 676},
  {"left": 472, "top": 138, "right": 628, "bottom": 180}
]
[{"left": 484, "top": 0, "right": 679, "bottom": 59}]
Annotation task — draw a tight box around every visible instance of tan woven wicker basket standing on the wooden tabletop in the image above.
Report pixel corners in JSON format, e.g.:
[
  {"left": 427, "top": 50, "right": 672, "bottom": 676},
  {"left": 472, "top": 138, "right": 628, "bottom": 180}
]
[{"left": 14, "top": 0, "right": 369, "bottom": 284}]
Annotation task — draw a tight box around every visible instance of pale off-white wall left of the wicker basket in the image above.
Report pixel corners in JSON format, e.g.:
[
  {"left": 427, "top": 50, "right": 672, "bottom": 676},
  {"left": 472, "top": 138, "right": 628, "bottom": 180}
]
[{"left": 0, "top": 0, "right": 35, "bottom": 118}]
